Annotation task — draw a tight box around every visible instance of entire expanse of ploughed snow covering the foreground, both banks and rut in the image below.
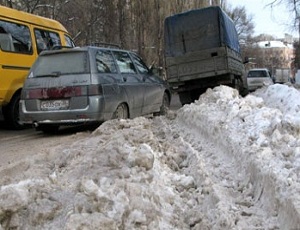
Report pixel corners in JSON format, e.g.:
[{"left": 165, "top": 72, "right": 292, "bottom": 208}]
[{"left": 0, "top": 84, "right": 300, "bottom": 230}]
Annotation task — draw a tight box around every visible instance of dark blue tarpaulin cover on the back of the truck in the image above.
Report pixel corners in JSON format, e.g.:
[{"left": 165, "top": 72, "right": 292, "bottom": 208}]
[{"left": 164, "top": 7, "right": 240, "bottom": 56}]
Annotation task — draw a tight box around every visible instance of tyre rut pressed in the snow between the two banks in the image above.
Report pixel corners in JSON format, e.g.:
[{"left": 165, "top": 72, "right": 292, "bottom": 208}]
[{"left": 154, "top": 111, "right": 279, "bottom": 229}]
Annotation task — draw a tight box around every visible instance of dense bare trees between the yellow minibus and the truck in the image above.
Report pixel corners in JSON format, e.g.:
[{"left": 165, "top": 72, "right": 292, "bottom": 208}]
[{"left": 0, "top": 0, "right": 237, "bottom": 66}]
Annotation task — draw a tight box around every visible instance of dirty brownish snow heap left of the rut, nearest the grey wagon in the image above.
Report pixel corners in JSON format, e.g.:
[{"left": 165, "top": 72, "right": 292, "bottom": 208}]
[{"left": 0, "top": 118, "right": 195, "bottom": 229}]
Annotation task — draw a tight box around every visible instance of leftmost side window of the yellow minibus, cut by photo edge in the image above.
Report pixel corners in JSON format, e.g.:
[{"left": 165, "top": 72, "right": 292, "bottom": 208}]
[{"left": 0, "top": 20, "right": 32, "bottom": 54}]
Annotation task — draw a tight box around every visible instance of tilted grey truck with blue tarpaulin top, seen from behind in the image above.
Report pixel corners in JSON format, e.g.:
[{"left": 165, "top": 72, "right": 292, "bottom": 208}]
[{"left": 164, "top": 6, "right": 248, "bottom": 104}]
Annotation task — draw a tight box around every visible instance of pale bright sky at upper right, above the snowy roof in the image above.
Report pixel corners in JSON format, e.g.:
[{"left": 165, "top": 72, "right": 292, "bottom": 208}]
[{"left": 228, "top": 0, "right": 298, "bottom": 38}]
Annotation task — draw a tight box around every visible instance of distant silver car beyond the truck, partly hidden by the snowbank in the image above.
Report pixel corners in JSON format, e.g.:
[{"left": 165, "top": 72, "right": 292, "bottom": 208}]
[{"left": 247, "top": 68, "right": 274, "bottom": 91}]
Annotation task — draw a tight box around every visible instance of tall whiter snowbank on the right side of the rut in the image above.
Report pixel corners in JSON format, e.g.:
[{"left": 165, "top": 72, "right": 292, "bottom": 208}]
[{"left": 178, "top": 84, "right": 300, "bottom": 229}]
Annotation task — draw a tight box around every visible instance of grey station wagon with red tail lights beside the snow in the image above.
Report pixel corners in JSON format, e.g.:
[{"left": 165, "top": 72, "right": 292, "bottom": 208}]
[{"left": 20, "top": 46, "right": 171, "bottom": 132}]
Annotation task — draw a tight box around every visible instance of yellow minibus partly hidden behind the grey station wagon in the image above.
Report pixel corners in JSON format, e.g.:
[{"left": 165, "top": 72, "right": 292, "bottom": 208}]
[{"left": 0, "top": 6, "right": 75, "bottom": 129}]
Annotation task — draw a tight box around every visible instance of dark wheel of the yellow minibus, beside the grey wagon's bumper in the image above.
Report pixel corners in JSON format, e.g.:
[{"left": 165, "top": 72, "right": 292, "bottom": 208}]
[{"left": 2, "top": 94, "right": 24, "bottom": 130}]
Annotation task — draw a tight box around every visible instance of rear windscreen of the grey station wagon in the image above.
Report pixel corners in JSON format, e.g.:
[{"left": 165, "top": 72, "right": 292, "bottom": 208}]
[{"left": 32, "top": 52, "right": 90, "bottom": 77}]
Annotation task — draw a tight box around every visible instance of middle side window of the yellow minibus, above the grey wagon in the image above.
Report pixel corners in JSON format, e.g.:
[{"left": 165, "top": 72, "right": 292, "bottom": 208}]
[{"left": 34, "top": 29, "right": 61, "bottom": 53}]
